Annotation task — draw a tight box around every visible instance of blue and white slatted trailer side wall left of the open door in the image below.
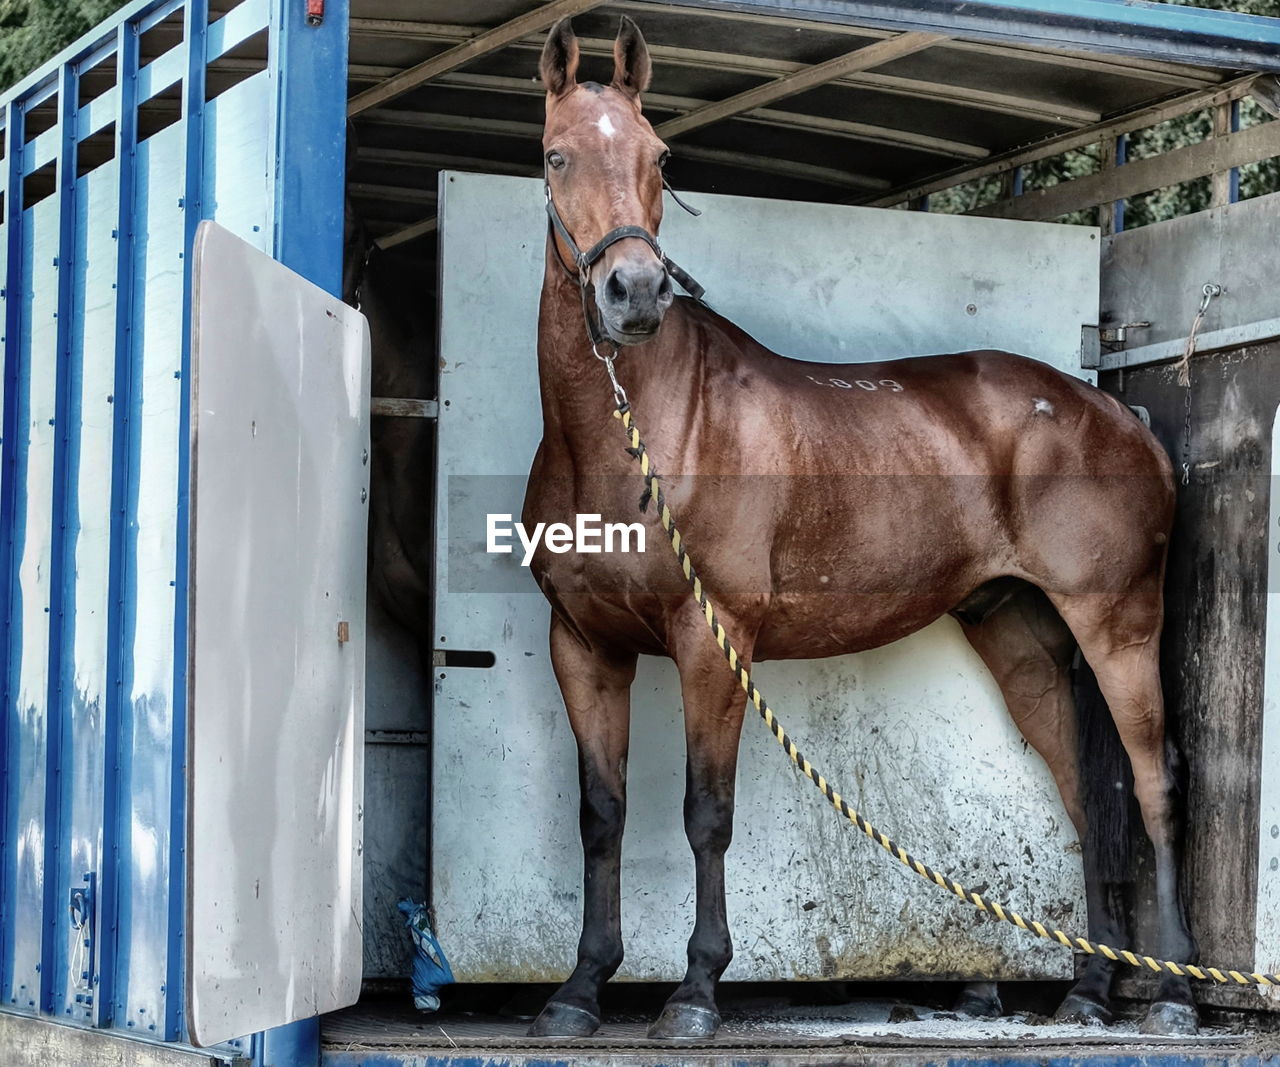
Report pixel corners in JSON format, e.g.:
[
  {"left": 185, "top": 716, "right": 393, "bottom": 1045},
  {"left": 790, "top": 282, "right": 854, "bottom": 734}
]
[{"left": 0, "top": 0, "right": 347, "bottom": 1041}]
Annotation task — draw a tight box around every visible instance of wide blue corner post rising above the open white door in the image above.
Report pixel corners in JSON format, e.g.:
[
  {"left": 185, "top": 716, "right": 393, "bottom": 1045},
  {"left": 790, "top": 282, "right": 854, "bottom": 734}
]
[{"left": 270, "top": 0, "right": 351, "bottom": 296}]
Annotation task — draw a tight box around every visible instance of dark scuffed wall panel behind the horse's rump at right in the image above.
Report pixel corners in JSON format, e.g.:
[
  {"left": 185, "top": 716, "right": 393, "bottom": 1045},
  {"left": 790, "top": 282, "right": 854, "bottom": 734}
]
[{"left": 1102, "top": 342, "right": 1280, "bottom": 1008}]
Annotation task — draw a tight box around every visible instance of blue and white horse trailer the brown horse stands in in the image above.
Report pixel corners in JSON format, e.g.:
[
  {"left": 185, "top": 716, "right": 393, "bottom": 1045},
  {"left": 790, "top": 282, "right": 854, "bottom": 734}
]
[{"left": 0, "top": 0, "right": 1280, "bottom": 1067}]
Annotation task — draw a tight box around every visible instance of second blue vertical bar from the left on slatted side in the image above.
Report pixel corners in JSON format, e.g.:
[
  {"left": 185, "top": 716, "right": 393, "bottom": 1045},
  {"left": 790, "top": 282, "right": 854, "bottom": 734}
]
[{"left": 40, "top": 63, "right": 79, "bottom": 1012}]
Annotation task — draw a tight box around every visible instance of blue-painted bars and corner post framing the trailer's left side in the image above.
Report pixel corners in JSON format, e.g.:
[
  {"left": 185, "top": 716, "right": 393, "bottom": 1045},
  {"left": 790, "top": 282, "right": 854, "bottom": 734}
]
[{"left": 0, "top": 0, "right": 348, "bottom": 1063}]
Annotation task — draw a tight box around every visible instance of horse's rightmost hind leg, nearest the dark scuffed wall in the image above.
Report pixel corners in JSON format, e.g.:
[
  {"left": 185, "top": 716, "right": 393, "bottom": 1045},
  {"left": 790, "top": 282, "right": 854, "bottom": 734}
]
[{"left": 1055, "top": 574, "right": 1199, "bottom": 1034}]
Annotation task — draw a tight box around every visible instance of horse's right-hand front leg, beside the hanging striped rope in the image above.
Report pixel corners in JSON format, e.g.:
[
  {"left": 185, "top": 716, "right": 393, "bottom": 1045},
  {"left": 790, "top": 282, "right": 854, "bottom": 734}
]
[{"left": 649, "top": 614, "right": 751, "bottom": 1039}]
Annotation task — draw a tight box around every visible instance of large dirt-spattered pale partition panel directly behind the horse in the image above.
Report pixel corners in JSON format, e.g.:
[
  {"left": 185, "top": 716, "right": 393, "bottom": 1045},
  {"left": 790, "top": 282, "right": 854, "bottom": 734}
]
[{"left": 431, "top": 174, "right": 1098, "bottom": 981}]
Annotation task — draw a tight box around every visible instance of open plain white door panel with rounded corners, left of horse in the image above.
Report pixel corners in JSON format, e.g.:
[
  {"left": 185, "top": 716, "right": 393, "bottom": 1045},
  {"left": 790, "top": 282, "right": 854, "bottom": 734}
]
[{"left": 187, "top": 223, "right": 369, "bottom": 1045}]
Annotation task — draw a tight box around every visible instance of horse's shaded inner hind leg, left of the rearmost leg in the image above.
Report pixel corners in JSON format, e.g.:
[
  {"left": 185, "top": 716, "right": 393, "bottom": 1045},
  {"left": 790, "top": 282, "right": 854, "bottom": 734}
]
[{"left": 954, "top": 581, "right": 1128, "bottom": 1022}]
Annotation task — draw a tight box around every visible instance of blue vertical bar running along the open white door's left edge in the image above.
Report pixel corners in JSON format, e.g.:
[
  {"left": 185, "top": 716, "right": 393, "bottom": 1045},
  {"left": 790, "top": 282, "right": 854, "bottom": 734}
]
[{"left": 165, "top": 0, "right": 209, "bottom": 1041}]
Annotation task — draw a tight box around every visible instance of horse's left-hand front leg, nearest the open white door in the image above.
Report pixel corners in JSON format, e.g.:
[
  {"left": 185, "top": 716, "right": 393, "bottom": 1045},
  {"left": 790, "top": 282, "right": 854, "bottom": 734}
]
[{"left": 529, "top": 615, "right": 636, "bottom": 1038}]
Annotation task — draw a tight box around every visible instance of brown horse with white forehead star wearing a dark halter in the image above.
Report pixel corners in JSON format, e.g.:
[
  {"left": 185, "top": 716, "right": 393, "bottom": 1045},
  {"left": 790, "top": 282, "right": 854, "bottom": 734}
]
[{"left": 524, "top": 19, "right": 1197, "bottom": 1038}]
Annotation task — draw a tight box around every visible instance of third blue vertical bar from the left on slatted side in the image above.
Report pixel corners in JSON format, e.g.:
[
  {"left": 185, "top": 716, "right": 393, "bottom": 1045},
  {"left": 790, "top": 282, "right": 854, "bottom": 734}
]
[{"left": 96, "top": 22, "right": 138, "bottom": 1026}]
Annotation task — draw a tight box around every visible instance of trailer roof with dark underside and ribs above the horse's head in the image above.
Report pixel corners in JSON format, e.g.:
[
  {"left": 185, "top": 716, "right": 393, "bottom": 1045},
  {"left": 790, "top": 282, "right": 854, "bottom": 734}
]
[{"left": 351, "top": 0, "right": 1280, "bottom": 248}]
